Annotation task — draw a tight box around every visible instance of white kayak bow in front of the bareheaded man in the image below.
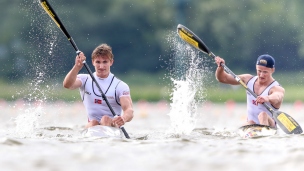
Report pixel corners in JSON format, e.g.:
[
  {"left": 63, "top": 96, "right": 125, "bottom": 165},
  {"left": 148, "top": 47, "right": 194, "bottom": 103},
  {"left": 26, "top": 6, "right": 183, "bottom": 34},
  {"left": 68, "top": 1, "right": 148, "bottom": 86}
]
[{"left": 82, "top": 125, "right": 122, "bottom": 138}]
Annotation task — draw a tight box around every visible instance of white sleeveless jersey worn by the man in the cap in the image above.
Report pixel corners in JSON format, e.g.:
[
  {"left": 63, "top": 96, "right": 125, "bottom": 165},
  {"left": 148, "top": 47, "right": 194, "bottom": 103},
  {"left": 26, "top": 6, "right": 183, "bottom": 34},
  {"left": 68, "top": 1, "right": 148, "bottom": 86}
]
[{"left": 246, "top": 76, "right": 280, "bottom": 124}]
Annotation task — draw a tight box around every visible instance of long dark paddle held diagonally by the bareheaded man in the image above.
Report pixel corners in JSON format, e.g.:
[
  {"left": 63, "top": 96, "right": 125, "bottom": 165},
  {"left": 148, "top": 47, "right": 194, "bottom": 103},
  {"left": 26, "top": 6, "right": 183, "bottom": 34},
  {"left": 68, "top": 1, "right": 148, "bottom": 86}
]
[{"left": 40, "top": 0, "right": 130, "bottom": 138}]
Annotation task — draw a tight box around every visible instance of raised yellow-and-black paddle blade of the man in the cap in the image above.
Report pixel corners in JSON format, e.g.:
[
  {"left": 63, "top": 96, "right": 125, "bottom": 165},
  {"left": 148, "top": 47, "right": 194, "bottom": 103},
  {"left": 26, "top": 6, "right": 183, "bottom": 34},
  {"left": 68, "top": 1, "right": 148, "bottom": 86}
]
[{"left": 177, "top": 24, "right": 211, "bottom": 55}]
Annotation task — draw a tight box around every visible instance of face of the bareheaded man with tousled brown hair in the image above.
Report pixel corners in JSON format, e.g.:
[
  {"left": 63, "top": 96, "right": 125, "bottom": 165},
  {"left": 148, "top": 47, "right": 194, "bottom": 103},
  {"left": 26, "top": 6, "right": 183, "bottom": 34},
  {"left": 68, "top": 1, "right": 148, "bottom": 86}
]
[{"left": 92, "top": 56, "right": 114, "bottom": 78}]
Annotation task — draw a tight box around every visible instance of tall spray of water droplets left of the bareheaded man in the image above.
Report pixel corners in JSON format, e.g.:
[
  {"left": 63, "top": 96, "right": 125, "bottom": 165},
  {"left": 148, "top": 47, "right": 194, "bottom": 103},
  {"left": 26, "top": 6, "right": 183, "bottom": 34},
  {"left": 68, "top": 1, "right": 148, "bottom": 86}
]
[{"left": 15, "top": 1, "right": 68, "bottom": 137}]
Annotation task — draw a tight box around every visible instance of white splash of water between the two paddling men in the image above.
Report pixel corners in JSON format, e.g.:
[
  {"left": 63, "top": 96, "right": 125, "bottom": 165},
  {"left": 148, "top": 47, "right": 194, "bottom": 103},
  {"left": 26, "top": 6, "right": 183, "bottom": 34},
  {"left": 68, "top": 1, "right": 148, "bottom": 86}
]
[{"left": 167, "top": 32, "right": 210, "bottom": 135}]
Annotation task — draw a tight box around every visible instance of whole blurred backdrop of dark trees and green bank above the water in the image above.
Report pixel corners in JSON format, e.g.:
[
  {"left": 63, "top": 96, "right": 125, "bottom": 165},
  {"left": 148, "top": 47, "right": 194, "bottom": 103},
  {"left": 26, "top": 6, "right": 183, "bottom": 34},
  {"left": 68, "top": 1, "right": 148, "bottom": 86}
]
[{"left": 0, "top": 0, "right": 304, "bottom": 102}]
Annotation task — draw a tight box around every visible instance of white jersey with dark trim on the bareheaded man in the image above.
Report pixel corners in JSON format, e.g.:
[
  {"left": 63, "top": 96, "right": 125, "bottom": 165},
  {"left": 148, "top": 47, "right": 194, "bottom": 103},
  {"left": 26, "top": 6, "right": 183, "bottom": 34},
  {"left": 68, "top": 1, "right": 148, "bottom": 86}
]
[{"left": 77, "top": 72, "right": 130, "bottom": 122}]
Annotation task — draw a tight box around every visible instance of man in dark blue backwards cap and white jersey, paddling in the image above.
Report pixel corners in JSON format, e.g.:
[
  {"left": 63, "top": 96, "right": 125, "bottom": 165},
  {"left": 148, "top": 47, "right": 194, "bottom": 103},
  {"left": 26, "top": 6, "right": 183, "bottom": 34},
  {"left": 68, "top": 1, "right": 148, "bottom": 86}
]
[{"left": 215, "top": 55, "right": 285, "bottom": 127}]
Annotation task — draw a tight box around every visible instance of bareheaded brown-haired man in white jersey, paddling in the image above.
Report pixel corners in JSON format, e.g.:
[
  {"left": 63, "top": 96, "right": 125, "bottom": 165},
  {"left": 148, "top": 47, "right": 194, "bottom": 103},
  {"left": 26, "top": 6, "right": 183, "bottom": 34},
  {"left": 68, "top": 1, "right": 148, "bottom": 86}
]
[{"left": 63, "top": 44, "right": 133, "bottom": 128}]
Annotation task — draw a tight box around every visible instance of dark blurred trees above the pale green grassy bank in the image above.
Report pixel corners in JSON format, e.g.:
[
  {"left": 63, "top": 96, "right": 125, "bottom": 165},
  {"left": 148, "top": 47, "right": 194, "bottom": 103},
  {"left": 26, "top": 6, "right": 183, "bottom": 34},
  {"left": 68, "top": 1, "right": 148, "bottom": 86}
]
[{"left": 0, "top": 0, "right": 304, "bottom": 80}]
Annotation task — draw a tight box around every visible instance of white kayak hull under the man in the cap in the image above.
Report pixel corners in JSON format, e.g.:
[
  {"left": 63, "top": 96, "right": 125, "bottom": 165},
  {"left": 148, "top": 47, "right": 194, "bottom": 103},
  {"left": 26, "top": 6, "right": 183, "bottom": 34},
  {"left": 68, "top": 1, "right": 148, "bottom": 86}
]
[{"left": 238, "top": 124, "right": 277, "bottom": 138}]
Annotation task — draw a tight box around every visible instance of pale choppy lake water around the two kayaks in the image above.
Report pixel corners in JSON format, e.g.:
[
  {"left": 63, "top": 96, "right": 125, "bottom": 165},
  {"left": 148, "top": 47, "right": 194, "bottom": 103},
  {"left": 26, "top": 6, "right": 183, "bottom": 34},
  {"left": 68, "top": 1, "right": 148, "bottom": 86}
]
[{"left": 0, "top": 101, "right": 304, "bottom": 171}]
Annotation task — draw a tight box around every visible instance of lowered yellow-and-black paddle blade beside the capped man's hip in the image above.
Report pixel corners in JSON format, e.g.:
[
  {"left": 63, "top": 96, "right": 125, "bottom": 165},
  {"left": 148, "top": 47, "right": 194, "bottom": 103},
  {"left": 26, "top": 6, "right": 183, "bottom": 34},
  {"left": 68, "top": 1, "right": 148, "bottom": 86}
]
[{"left": 274, "top": 111, "right": 303, "bottom": 134}]
